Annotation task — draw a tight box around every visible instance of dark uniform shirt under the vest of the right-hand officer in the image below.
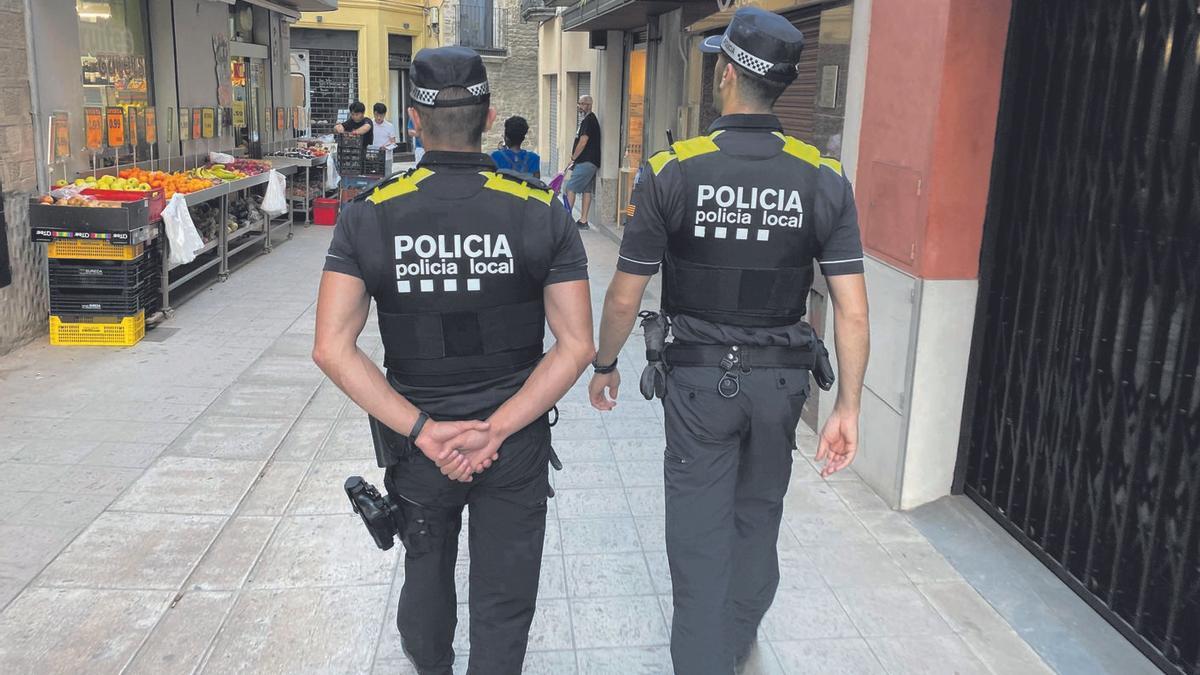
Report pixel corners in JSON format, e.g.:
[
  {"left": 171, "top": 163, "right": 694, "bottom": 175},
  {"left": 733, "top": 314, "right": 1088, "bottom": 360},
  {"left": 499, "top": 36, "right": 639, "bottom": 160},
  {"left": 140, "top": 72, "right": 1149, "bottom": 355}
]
[{"left": 617, "top": 115, "right": 863, "bottom": 346}]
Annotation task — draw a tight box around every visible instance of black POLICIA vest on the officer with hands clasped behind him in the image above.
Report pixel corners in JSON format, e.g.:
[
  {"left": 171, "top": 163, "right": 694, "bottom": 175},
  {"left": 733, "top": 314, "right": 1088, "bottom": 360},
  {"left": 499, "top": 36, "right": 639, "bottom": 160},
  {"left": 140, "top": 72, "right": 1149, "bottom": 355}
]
[{"left": 366, "top": 168, "right": 551, "bottom": 387}]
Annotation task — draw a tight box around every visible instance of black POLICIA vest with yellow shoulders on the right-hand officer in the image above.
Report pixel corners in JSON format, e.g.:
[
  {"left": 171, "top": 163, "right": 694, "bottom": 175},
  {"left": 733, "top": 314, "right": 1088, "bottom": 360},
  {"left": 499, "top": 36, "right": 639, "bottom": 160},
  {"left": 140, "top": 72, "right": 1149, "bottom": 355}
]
[{"left": 649, "top": 131, "right": 840, "bottom": 327}]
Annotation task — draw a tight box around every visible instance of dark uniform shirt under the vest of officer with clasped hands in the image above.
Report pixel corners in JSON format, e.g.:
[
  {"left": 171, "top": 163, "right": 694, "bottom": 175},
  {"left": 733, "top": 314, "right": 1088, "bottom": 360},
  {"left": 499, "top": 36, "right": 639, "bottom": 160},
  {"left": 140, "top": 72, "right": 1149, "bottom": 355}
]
[{"left": 325, "top": 151, "right": 588, "bottom": 419}]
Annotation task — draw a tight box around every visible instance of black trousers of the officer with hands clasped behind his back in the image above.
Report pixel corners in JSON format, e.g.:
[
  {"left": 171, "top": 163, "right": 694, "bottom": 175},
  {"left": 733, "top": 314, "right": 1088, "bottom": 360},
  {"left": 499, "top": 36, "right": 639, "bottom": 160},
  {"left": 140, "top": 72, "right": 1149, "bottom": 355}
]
[{"left": 384, "top": 418, "right": 551, "bottom": 675}]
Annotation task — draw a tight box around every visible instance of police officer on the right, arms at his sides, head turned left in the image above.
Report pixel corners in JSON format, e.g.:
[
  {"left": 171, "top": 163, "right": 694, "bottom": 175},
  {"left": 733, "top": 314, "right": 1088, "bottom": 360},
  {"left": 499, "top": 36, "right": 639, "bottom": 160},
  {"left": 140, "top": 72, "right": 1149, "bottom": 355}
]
[{"left": 590, "top": 7, "right": 868, "bottom": 675}]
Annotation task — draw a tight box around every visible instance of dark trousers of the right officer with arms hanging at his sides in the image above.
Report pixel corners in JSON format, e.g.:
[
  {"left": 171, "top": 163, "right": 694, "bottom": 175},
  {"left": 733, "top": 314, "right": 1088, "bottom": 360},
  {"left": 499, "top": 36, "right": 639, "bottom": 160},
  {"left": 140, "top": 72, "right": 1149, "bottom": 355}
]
[{"left": 662, "top": 368, "right": 809, "bottom": 675}]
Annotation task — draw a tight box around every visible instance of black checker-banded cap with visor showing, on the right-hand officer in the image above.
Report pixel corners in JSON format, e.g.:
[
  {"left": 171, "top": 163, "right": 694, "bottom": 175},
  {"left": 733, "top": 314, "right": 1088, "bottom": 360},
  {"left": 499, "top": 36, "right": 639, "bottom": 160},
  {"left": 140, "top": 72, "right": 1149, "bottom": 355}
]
[{"left": 700, "top": 7, "right": 804, "bottom": 84}]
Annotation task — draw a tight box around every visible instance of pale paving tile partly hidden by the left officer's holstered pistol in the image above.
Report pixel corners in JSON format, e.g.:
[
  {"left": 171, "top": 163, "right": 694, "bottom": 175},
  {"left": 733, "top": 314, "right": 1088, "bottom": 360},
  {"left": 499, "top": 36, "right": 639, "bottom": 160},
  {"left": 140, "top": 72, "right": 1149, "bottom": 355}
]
[{"left": 247, "top": 514, "right": 396, "bottom": 589}]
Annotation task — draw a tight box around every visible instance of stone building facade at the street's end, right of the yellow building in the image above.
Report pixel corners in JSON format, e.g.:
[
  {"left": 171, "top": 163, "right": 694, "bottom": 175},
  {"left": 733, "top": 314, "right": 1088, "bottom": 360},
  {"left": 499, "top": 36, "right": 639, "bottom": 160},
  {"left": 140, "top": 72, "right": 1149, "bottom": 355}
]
[{"left": 442, "top": 0, "right": 537, "bottom": 156}]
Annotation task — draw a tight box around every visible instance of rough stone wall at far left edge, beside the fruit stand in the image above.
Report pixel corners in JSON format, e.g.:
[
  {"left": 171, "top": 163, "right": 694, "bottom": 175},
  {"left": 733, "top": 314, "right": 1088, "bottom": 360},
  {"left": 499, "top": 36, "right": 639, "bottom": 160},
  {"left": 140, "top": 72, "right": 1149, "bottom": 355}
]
[{"left": 0, "top": 0, "right": 49, "bottom": 354}]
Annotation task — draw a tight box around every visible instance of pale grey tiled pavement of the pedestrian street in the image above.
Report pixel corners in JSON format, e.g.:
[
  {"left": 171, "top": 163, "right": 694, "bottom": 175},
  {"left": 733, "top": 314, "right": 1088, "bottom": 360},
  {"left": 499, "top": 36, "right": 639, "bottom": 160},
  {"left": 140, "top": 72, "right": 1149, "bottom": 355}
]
[{"left": 0, "top": 228, "right": 1049, "bottom": 675}]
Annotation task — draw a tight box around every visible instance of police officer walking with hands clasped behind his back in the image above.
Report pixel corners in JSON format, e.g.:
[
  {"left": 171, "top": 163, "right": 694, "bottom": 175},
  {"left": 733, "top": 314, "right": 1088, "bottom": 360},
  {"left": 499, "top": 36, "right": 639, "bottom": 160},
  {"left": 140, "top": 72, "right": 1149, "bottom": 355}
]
[{"left": 313, "top": 47, "right": 594, "bottom": 675}]
